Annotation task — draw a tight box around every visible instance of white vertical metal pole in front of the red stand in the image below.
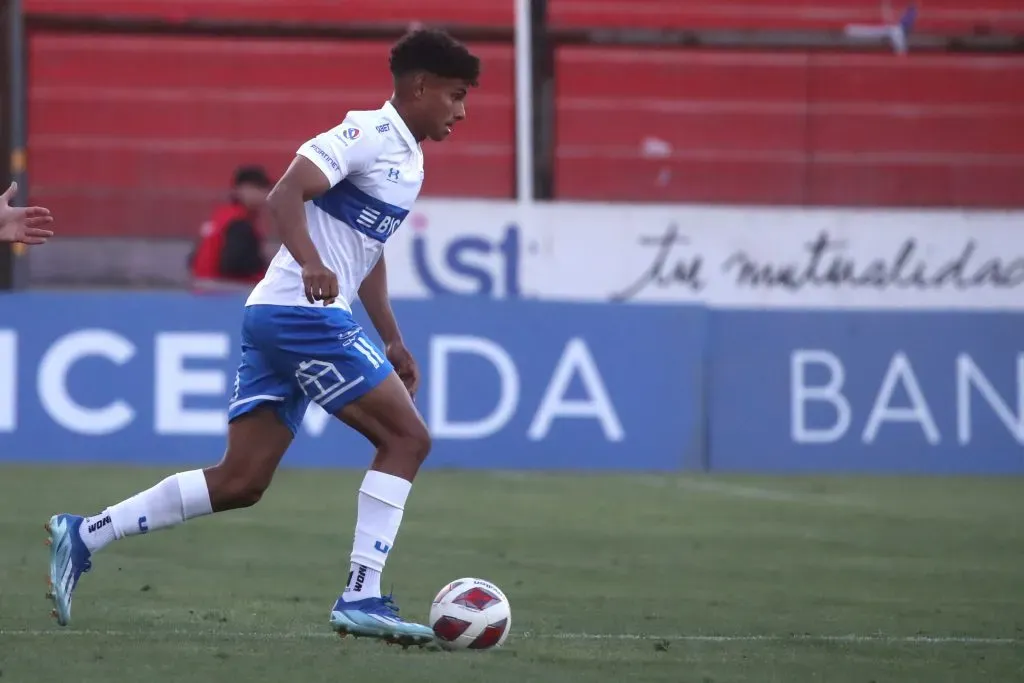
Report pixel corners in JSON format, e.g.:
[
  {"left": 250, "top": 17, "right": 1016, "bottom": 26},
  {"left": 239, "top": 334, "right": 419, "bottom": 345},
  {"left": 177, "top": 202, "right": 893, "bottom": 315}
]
[{"left": 515, "top": 0, "right": 534, "bottom": 204}]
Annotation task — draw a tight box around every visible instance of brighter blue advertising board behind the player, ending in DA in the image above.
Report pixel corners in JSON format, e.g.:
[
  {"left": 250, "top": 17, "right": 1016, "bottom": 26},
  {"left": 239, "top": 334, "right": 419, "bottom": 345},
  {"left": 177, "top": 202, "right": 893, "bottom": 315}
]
[{"left": 0, "top": 293, "right": 708, "bottom": 470}]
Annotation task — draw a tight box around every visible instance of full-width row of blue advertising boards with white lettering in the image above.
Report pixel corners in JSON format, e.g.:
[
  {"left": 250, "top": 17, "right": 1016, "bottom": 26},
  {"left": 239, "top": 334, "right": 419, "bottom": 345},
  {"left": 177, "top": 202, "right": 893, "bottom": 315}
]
[{"left": 0, "top": 293, "right": 1024, "bottom": 474}]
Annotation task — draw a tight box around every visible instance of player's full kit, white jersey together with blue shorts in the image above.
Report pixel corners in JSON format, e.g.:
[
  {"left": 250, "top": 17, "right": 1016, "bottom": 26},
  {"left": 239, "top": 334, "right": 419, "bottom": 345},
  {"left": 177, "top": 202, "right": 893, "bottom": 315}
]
[{"left": 228, "top": 102, "right": 423, "bottom": 433}]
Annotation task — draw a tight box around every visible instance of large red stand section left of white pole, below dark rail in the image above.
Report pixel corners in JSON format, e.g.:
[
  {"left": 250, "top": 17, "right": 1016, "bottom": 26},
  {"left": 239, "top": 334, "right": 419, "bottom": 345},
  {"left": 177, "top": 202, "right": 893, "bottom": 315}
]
[{"left": 29, "top": 36, "right": 514, "bottom": 237}]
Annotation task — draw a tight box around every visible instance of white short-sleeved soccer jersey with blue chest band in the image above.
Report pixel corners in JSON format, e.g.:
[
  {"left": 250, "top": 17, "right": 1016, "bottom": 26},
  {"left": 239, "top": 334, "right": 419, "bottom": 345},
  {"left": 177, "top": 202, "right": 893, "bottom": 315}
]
[{"left": 246, "top": 102, "right": 423, "bottom": 310}]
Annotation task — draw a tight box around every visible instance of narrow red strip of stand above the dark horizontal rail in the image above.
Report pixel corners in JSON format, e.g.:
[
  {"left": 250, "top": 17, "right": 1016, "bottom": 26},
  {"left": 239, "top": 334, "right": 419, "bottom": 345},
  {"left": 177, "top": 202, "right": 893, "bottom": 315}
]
[{"left": 25, "top": 0, "right": 1024, "bottom": 33}]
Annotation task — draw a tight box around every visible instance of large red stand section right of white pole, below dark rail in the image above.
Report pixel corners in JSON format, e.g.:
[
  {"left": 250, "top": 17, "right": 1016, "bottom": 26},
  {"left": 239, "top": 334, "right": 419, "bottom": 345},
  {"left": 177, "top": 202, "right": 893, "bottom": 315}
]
[{"left": 555, "top": 48, "right": 1024, "bottom": 207}]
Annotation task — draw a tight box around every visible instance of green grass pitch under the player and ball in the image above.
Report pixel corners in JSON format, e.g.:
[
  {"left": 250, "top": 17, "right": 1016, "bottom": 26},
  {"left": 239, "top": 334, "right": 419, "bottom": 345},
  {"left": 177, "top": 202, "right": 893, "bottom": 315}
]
[{"left": 0, "top": 467, "right": 1024, "bottom": 683}]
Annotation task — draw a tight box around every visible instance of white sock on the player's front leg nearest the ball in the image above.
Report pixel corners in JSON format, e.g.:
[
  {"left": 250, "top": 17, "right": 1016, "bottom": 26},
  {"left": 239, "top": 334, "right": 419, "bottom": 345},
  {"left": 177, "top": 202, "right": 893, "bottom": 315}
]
[{"left": 342, "top": 470, "right": 413, "bottom": 600}]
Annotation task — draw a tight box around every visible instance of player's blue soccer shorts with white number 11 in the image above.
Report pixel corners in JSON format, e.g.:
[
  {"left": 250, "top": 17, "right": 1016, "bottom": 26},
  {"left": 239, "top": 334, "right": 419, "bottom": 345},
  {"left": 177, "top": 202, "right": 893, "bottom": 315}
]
[{"left": 227, "top": 305, "right": 392, "bottom": 434}]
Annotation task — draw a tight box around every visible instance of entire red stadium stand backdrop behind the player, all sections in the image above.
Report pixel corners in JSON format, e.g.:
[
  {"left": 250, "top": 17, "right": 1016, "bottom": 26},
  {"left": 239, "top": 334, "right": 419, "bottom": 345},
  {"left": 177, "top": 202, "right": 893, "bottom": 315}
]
[{"left": 27, "top": 0, "right": 1024, "bottom": 237}]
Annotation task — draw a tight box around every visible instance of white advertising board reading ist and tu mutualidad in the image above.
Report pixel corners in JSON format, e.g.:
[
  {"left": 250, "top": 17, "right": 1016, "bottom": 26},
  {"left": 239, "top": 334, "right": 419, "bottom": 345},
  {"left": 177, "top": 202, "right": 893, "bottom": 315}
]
[{"left": 385, "top": 200, "right": 1024, "bottom": 309}]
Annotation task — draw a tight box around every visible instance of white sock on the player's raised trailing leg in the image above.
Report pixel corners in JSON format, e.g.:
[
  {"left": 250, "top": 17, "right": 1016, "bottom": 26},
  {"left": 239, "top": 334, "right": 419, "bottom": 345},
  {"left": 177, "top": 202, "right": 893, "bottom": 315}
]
[{"left": 79, "top": 470, "right": 213, "bottom": 553}]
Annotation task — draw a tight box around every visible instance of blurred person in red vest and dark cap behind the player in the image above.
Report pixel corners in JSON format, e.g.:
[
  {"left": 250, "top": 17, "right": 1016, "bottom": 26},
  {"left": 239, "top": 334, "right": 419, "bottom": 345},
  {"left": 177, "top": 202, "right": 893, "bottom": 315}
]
[{"left": 188, "top": 166, "right": 273, "bottom": 291}]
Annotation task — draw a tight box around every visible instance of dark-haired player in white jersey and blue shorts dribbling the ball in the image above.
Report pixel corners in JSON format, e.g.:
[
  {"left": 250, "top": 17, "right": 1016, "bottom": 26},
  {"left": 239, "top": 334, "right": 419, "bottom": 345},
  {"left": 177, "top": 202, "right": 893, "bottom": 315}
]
[{"left": 46, "top": 30, "right": 480, "bottom": 645}]
